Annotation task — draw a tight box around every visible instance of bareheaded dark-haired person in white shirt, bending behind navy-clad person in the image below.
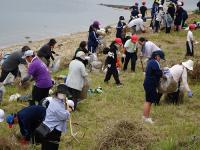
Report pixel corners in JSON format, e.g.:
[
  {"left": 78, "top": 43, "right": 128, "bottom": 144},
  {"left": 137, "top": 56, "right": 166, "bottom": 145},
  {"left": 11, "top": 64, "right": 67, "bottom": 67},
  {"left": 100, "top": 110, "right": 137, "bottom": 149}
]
[{"left": 138, "top": 37, "right": 162, "bottom": 59}]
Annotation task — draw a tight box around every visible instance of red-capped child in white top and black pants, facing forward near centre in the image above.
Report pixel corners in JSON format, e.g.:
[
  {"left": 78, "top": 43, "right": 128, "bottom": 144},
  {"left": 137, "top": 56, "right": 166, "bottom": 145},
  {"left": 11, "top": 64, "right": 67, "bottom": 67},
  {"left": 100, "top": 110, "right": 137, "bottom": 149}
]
[{"left": 123, "top": 34, "right": 138, "bottom": 72}]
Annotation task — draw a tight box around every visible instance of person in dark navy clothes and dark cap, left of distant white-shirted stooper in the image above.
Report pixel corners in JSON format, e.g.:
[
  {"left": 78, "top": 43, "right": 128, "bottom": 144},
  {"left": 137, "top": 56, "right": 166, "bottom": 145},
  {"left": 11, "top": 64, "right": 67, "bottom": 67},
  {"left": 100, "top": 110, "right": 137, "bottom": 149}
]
[{"left": 116, "top": 16, "right": 126, "bottom": 42}]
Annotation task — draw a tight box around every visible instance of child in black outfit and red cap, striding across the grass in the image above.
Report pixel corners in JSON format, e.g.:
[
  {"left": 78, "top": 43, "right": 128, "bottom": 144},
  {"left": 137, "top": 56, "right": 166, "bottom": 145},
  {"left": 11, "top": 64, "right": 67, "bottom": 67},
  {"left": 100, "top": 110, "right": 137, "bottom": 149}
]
[{"left": 104, "top": 38, "right": 123, "bottom": 86}]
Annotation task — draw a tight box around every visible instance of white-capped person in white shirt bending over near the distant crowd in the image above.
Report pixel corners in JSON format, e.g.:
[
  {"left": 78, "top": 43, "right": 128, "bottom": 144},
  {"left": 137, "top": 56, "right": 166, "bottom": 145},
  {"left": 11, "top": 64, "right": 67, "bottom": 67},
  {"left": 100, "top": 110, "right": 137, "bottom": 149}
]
[{"left": 127, "top": 14, "right": 145, "bottom": 34}]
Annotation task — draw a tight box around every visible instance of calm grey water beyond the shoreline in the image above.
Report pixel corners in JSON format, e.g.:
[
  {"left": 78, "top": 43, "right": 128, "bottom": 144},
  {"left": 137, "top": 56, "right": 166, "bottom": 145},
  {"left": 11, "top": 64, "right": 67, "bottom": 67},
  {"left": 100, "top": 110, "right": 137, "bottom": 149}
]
[{"left": 0, "top": 0, "right": 198, "bottom": 47}]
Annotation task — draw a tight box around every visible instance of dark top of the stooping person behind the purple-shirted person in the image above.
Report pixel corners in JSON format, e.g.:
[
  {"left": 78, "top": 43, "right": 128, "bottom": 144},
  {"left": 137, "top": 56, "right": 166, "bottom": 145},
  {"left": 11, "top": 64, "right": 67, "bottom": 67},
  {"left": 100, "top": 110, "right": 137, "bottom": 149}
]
[{"left": 37, "top": 44, "right": 54, "bottom": 60}]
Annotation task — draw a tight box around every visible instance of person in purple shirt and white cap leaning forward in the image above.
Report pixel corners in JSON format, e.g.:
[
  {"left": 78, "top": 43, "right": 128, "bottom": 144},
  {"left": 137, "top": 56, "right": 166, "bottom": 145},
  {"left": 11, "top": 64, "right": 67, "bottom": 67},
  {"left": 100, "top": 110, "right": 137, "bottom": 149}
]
[{"left": 21, "top": 50, "right": 52, "bottom": 105}]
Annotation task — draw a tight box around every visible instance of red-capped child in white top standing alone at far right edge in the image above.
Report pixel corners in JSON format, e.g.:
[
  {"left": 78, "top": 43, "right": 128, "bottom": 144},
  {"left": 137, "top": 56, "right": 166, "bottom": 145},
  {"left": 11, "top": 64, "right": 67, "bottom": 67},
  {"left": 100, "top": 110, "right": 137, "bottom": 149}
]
[{"left": 186, "top": 24, "right": 195, "bottom": 56}]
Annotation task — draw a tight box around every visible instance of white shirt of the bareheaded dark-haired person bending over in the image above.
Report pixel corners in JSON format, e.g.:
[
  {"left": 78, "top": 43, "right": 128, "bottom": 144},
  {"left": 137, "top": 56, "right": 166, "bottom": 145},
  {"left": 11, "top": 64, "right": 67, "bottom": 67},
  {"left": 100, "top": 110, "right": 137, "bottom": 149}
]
[{"left": 142, "top": 41, "right": 161, "bottom": 58}]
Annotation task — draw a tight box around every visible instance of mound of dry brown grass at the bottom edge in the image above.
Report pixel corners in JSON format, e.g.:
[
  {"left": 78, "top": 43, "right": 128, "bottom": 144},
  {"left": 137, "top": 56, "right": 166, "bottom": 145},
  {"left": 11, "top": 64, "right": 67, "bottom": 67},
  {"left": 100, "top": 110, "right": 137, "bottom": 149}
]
[{"left": 96, "top": 121, "right": 155, "bottom": 150}]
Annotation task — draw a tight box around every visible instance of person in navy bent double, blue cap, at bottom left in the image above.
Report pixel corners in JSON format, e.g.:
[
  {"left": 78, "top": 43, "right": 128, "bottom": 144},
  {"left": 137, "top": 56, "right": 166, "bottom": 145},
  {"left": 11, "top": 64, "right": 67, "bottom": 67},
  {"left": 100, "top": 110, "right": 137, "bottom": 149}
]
[{"left": 6, "top": 105, "right": 46, "bottom": 144}]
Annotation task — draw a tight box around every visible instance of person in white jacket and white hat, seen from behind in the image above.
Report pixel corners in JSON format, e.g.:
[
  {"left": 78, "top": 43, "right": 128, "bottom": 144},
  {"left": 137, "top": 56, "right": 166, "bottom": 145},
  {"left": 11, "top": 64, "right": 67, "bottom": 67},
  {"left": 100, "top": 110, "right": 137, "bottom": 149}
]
[{"left": 65, "top": 51, "right": 88, "bottom": 109}]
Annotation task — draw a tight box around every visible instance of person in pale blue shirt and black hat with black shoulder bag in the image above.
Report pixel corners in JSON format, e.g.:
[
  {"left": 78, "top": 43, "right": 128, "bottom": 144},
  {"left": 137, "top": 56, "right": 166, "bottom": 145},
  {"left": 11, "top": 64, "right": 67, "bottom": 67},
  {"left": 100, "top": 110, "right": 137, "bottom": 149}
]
[{"left": 35, "top": 84, "right": 74, "bottom": 150}]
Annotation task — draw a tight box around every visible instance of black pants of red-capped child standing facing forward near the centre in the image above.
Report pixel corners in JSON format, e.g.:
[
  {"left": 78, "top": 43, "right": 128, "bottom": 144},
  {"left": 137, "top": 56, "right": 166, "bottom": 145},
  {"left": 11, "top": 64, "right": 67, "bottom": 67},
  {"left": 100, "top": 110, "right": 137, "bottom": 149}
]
[{"left": 123, "top": 51, "right": 137, "bottom": 72}]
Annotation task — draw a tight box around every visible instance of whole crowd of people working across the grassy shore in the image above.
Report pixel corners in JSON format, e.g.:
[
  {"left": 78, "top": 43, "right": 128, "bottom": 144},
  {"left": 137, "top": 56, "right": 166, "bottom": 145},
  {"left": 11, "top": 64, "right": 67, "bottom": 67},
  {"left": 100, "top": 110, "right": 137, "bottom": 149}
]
[{"left": 0, "top": 0, "right": 195, "bottom": 150}]
